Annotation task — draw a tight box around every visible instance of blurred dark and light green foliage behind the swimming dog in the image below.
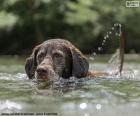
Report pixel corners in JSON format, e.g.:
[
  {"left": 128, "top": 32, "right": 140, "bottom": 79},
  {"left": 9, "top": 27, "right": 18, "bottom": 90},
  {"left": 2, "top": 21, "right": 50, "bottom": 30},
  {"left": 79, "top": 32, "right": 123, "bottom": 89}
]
[{"left": 0, "top": 0, "right": 140, "bottom": 54}]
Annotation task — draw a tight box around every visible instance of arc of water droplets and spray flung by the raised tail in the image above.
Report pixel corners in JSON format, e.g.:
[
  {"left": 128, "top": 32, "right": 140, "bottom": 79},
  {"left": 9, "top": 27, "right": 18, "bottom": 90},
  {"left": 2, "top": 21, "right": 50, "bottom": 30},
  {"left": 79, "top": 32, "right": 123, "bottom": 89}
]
[{"left": 90, "top": 23, "right": 124, "bottom": 73}]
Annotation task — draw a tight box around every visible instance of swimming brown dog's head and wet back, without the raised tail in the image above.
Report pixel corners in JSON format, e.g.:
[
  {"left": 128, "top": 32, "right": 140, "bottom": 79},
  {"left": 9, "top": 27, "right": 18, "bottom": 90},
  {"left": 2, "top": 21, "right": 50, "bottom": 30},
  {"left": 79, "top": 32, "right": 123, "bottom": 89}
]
[{"left": 25, "top": 39, "right": 120, "bottom": 81}]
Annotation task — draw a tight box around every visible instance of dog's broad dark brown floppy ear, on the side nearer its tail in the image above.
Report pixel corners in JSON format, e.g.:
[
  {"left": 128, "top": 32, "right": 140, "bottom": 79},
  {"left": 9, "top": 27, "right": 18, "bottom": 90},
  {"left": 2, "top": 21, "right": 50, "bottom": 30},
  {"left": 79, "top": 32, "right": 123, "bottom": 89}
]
[{"left": 70, "top": 46, "right": 89, "bottom": 78}]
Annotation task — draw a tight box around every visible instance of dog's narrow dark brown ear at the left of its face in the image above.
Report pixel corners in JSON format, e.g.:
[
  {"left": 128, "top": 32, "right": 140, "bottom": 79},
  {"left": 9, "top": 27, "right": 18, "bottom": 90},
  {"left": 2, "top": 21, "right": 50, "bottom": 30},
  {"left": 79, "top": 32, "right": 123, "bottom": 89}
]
[{"left": 25, "top": 46, "right": 39, "bottom": 79}]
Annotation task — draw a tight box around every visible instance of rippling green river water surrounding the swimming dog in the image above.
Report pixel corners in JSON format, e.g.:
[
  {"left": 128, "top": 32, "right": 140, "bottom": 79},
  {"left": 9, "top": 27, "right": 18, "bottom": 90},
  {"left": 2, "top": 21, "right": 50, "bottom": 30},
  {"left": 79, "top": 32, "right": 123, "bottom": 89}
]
[{"left": 0, "top": 57, "right": 140, "bottom": 116}]
